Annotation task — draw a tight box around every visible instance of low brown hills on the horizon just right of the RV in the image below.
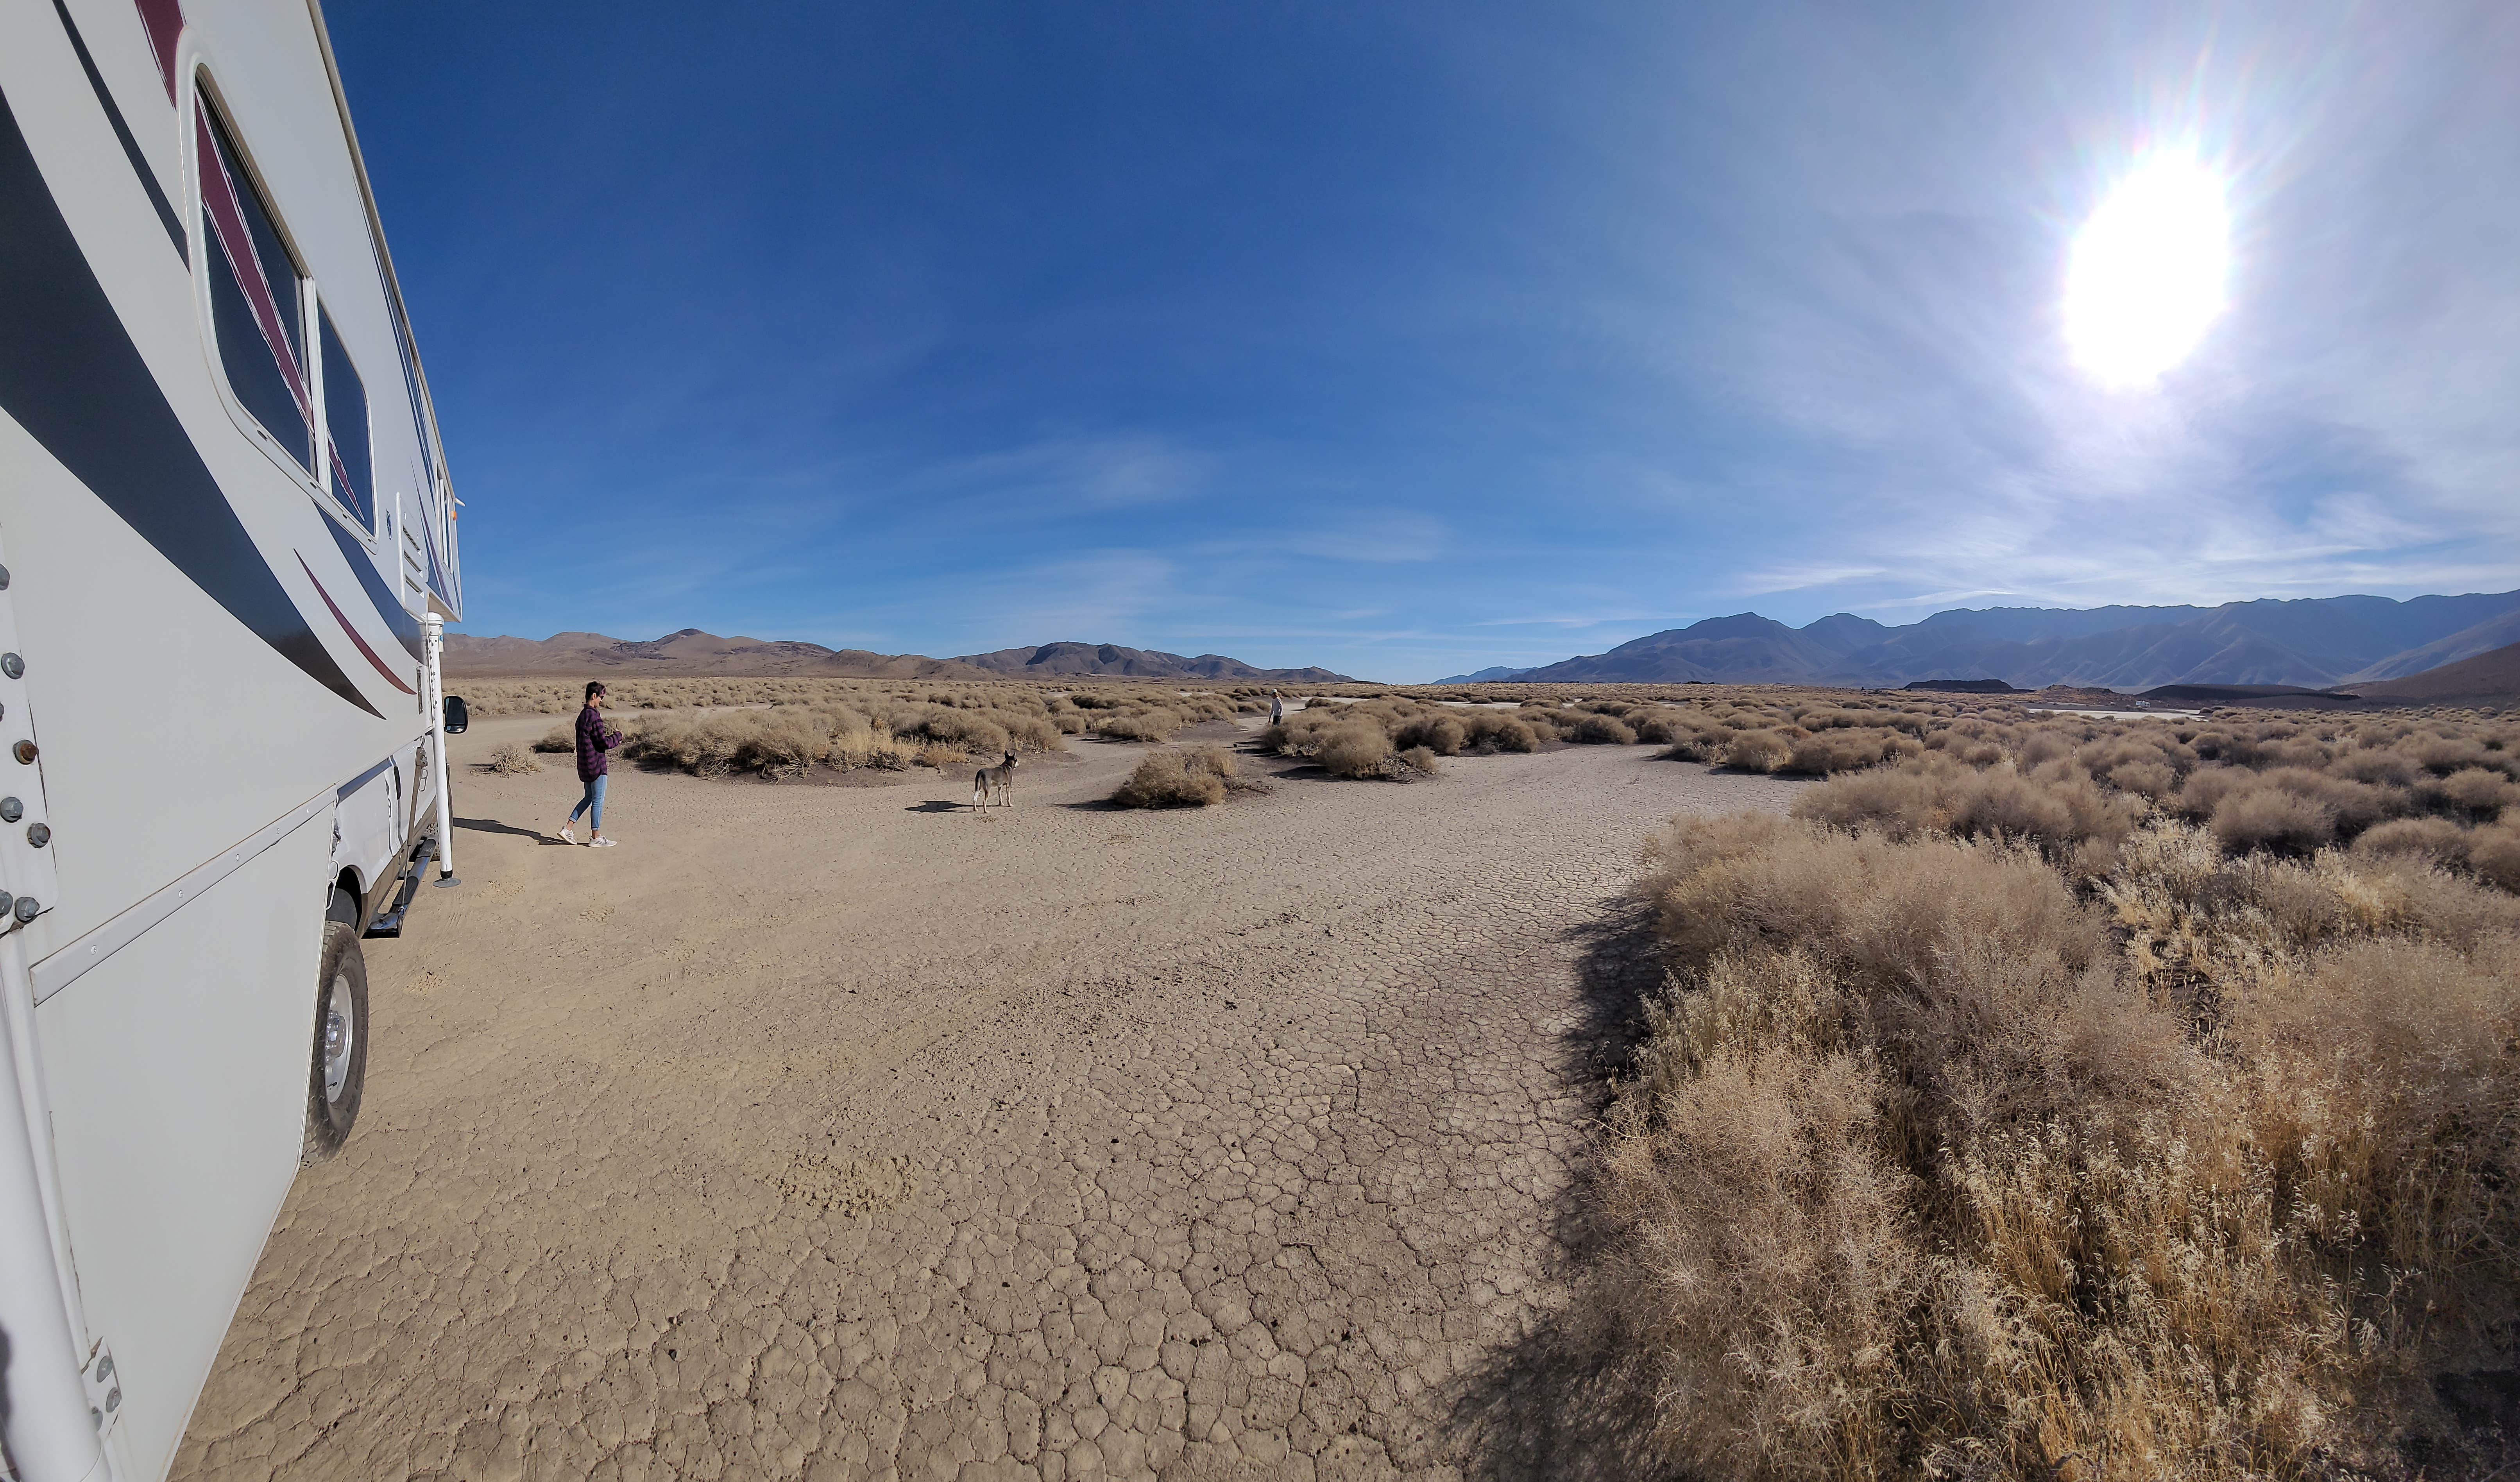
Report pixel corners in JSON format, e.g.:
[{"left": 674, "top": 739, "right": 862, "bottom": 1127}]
[{"left": 446, "top": 628, "right": 1348, "bottom": 686}]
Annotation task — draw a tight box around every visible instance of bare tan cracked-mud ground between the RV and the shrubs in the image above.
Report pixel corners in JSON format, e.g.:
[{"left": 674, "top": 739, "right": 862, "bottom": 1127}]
[{"left": 176, "top": 716, "right": 1794, "bottom": 1482}]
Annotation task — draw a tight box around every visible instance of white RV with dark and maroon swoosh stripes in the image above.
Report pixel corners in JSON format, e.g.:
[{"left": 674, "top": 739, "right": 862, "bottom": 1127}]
[{"left": 0, "top": 0, "right": 464, "bottom": 1482}]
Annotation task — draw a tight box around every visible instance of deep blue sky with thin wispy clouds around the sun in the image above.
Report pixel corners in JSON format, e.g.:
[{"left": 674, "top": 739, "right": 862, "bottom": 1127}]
[{"left": 328, "top": 0, "right": 2520, "bottom": 680}]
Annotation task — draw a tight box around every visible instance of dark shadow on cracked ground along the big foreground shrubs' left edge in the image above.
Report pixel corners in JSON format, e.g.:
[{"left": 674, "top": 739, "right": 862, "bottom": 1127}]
[{"left": 1446, "top": 902, "right": 1676, "bottom": 1482}]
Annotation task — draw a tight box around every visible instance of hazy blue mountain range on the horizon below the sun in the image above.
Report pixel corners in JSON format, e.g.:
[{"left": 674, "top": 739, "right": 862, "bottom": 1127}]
[{"left": 1436, "top": 592, "right": 2520, "bottom": 691}]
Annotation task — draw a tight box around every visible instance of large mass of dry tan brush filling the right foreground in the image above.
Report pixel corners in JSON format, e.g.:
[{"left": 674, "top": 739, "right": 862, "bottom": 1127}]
[{"left": 1582, "top": 806, "right": 2520, "bottom": 1480}]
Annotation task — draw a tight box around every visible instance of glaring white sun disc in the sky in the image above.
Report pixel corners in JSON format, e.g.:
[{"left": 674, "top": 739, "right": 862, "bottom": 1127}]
[{"left": 2064, "top": 154, "right": 2230, "bottom": 386}]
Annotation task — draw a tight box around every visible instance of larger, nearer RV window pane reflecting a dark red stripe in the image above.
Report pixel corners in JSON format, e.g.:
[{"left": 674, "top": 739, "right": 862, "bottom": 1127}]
[{"left": 197, "top": 98, "right": 315, "bottom": 469}]
